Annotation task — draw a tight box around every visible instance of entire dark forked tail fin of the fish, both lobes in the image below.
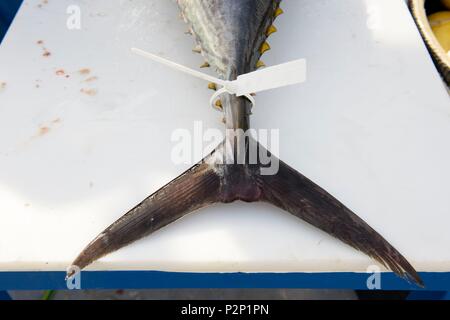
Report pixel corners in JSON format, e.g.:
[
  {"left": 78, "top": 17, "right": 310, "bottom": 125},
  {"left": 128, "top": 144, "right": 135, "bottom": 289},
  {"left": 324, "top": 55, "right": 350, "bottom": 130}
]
[{"left": 68, "top": 144, "right": 423, "bottom": 286}]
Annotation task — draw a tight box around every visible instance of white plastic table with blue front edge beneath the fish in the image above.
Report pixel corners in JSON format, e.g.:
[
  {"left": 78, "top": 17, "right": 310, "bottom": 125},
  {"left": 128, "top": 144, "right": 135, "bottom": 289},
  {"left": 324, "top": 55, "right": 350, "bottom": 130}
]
[{"left": 0, "top": 0, "right": 450, "bottom": 289}]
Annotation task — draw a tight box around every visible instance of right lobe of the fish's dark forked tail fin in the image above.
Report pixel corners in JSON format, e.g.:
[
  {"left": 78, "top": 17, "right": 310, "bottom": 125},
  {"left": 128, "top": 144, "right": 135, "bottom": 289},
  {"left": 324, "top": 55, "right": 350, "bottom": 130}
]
[{"left": 260, "top": 154, "right": 424, "bottom": 287}]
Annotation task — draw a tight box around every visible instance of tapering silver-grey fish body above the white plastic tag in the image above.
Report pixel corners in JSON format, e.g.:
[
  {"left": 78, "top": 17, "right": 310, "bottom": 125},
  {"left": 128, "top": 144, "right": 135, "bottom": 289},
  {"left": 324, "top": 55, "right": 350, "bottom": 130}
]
[{"left": 177, "top": 0, "right": 281, "bottom": 80}]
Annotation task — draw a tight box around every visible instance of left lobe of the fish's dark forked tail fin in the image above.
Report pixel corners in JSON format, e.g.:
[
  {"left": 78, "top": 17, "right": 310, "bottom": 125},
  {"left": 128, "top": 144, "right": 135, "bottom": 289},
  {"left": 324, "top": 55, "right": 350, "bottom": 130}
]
[{"left": 68, "top": 149, "right": 220, "bottom": 277}]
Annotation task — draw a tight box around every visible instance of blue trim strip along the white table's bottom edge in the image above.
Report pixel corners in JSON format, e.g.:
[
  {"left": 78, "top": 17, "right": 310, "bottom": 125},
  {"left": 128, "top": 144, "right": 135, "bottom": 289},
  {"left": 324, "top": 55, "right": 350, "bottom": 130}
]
[{"left": 0, "top": 271, "right": 450, "bottom": 291}]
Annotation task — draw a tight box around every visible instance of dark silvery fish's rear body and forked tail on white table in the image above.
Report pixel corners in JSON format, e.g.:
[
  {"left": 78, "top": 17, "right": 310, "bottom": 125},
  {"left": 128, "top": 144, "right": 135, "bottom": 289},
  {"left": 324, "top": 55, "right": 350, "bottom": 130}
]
[{"left": 68, "top": 0, "right": 424, "bottom": 287}]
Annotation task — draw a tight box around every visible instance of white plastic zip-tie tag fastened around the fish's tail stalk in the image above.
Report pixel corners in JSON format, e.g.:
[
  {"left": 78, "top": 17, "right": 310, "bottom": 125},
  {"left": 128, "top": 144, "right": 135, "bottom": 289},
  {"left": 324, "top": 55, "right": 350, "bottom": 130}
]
[{"left": 131, "top": 48, "right": 307, "bottom": 101}]
